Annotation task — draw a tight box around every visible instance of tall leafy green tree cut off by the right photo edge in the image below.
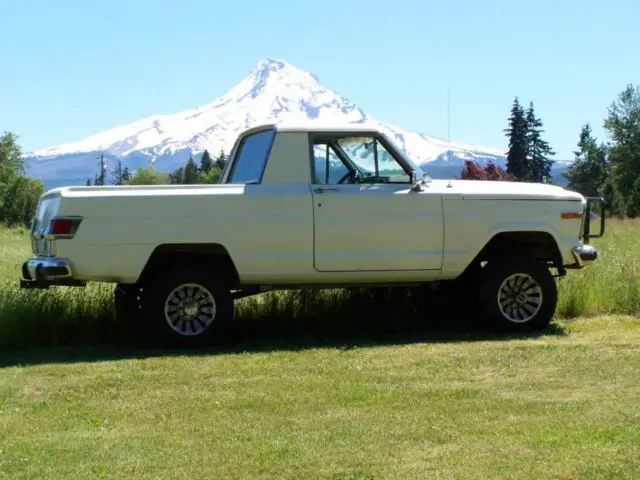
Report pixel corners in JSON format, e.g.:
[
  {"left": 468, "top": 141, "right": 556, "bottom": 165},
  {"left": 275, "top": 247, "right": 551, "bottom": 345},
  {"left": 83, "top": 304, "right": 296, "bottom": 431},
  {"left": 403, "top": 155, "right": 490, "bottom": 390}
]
[{"left": 604, "top": 85, "right": 640, "bottom": 217}]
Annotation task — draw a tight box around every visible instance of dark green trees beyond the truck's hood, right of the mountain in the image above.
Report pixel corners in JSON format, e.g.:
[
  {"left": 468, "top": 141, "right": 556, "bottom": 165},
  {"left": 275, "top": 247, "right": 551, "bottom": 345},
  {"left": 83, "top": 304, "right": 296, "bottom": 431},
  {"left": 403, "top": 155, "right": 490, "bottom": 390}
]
[{"left": 458, "top": 84, "right": 640, "bottom": 218}]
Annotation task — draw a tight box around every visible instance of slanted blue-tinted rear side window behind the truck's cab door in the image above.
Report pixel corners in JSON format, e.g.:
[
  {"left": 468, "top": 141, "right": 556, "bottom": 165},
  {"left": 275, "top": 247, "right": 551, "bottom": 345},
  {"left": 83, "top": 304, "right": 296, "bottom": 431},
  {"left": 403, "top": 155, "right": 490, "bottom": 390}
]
[{"left": 227, "top": 130, "right": 274, "bottom": 184}]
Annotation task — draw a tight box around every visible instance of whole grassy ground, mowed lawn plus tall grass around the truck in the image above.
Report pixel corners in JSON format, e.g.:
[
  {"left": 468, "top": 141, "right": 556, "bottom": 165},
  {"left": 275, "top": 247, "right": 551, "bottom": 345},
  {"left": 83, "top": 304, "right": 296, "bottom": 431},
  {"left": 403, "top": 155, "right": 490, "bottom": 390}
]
[{"left": 0, "top": 222, "right": 640, "bottom": 479}]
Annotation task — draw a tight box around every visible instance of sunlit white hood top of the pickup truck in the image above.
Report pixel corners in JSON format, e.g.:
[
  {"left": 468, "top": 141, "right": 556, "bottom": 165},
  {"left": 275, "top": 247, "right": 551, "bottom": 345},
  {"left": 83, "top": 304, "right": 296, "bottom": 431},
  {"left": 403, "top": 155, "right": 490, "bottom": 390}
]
[{"left": 431, "top": 180, "right": 584, "bottom": 202}]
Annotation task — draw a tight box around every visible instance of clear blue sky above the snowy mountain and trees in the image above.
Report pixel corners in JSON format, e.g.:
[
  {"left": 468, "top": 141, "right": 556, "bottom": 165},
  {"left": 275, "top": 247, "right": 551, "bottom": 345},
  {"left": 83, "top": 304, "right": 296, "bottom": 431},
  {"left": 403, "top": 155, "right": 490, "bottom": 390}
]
[{"left": 0, "top": 0, "right": 640, "bottom": 158}]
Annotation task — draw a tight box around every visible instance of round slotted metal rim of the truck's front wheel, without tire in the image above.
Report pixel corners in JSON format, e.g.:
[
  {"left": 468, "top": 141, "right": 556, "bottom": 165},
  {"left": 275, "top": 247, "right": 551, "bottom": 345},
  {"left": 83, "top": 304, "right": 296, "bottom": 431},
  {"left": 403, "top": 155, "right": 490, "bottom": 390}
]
[{"left": 498, "top": 273, "right": 542, "bottom": 323}]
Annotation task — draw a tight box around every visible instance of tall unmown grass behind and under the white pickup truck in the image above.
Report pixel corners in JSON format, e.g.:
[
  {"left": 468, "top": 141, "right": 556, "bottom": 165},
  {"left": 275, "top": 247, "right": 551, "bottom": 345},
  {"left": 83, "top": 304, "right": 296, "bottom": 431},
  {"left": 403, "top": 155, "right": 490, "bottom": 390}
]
[{"left": 0, "top": 220, "right": 640, "bottom": 348}]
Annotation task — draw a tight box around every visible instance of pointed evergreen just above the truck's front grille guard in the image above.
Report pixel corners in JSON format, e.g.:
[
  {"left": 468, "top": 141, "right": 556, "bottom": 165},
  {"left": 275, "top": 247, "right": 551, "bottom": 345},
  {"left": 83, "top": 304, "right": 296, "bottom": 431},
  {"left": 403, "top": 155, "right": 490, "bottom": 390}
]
[{"left": 565, "top": 123, "right": 609, "bottom": 197}]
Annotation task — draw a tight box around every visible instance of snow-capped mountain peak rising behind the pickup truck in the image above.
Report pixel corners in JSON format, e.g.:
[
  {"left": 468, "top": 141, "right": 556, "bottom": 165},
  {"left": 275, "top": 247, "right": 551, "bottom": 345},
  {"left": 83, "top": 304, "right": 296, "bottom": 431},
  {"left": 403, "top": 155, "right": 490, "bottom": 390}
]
[{"left": 26, "top": 59, "right": 568, "bottom": 188}]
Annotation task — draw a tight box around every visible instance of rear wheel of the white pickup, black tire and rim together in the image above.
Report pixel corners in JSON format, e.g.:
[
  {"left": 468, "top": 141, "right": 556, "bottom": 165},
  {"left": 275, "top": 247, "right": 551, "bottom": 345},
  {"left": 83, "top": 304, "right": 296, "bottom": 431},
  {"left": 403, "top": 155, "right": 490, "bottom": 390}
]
[{"left": 142, "top": 266, "right": 234, "bottom": 347}]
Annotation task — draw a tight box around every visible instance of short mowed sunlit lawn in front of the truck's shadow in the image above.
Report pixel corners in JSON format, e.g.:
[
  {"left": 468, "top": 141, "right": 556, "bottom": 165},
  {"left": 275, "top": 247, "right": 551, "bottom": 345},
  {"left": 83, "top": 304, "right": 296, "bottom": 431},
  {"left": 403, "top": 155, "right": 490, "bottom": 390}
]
[{"left": 0, "top": 316, "right": 640, "bottom": 479}]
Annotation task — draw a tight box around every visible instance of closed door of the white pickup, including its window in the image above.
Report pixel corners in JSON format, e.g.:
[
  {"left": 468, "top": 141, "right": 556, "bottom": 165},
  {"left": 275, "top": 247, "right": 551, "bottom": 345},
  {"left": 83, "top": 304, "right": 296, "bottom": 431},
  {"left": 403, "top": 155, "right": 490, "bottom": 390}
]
[{"left": 310, "top": 134, "right": 444, "bottom": 272}]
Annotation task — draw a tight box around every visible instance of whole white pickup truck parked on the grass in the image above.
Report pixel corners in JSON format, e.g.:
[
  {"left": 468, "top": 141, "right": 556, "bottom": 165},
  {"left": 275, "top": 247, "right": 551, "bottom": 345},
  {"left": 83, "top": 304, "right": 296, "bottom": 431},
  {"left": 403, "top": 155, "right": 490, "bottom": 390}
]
[{"left": 21, "top": 125, "right": 605, "bottom": 345}]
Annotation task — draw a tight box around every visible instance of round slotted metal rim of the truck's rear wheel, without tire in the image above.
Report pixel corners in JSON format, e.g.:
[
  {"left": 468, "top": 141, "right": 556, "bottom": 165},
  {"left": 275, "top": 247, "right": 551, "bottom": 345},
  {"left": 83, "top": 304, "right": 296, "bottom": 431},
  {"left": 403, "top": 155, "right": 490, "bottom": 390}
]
[{"left": 164, "top": 283, "right": 216, "bottom": 336}]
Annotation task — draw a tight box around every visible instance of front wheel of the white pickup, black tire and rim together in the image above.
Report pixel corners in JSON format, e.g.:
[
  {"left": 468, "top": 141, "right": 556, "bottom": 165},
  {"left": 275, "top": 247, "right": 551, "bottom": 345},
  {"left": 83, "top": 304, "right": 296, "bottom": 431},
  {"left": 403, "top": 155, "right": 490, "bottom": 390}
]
[{"left": 480, "top": 257, "right": 558, "bottom": 332}]
